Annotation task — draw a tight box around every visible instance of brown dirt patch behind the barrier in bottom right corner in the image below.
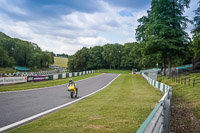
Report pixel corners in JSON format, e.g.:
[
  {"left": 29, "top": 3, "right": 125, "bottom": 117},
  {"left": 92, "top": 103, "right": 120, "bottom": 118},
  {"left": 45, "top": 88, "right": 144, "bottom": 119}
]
[{"left": 170, "top": 97, "right": 200, "bottom": 133}]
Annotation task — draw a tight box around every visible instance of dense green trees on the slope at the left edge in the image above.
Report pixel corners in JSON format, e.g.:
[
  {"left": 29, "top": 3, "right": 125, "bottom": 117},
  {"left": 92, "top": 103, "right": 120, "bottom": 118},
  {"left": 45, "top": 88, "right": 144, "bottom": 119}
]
[{"left": 0, "top": 32, "right": 54, "bottom": 68}]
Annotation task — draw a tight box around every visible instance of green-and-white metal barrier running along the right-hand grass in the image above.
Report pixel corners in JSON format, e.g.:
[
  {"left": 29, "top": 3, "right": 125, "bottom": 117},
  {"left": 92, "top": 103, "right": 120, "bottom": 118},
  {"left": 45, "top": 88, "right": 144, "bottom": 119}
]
[{"left": 137, "top": 73, "right": 172, "bottom": 133}]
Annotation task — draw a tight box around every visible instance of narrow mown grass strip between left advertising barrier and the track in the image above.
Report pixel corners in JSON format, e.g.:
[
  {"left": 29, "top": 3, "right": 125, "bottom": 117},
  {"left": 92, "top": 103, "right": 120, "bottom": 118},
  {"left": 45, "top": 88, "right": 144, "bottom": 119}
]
[{"left": 0, "top": 73, "right": 101, "bottom": 92}]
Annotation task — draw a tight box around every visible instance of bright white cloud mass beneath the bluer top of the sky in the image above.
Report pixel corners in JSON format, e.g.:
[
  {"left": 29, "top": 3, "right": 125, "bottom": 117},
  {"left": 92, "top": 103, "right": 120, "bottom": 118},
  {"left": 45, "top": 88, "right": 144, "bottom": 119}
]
[{"left": 0, "top": 0, "right": 152, "bottom": 55}]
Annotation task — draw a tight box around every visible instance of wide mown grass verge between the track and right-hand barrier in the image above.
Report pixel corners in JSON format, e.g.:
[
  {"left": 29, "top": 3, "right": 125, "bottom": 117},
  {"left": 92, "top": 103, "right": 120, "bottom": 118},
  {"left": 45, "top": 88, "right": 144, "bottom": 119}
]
[{"left": 9, "top": 74, "right": 162, "bottom": 133}]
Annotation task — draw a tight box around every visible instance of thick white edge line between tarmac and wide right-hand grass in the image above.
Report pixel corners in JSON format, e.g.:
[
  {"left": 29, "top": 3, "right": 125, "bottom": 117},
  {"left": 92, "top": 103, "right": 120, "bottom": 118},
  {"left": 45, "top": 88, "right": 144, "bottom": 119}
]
[{"left": 0, "top": 74, "right": 120, "bottom": 132}]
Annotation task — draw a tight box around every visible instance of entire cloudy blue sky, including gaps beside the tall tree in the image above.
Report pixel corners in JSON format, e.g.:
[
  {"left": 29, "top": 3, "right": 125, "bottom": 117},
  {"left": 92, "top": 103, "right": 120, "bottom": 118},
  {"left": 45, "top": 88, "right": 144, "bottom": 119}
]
[{"left": 0, "top": 0, "right": 198, "bottom": 55}]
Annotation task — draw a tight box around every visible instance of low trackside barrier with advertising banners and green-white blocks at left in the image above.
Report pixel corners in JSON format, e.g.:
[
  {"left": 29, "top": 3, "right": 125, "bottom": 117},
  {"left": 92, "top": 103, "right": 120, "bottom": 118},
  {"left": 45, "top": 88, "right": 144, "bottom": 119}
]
[{"left": 0, "top": 70, "right": 95, "bottom": 85}]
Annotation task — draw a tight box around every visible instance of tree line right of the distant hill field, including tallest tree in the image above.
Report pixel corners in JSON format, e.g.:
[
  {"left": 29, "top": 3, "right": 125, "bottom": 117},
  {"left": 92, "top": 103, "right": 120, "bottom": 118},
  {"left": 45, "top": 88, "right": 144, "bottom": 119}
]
[{"left": 68, "top": 0, "right": 200, "bottom": 75}]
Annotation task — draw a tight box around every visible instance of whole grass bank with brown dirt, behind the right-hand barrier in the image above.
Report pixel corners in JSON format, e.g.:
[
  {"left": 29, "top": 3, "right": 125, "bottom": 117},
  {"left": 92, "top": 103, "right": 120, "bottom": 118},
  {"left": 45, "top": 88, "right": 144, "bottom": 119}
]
[{"left": 158, "top": 73, "right": 200, "bottom": 133}]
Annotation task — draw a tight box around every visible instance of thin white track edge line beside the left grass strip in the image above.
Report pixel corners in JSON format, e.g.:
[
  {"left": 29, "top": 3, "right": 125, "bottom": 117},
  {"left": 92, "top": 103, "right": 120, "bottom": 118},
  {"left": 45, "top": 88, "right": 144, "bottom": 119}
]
[{"left": 0, "top": 73, "right": 105, "bottom": 94}]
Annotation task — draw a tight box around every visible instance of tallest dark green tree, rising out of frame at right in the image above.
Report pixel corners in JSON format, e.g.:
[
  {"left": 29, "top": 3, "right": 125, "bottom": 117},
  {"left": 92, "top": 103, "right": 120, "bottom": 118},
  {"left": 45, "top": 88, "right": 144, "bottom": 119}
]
[{"left": 136, "top": 0, "right": 190, "bottom": 75}]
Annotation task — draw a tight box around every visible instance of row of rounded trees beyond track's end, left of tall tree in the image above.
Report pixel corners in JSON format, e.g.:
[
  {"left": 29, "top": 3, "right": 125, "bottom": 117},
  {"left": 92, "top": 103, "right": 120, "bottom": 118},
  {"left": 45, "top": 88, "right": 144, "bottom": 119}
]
[{"left": 68, "top": 43, "right": 139, "bottom": 71}]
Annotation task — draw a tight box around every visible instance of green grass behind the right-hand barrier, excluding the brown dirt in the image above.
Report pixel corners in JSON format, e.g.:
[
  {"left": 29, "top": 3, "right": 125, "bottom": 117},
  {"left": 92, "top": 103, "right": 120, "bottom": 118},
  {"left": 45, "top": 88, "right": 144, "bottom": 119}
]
[{"left": 159, "top": 73, "right": 200, "bottom": 119}]
